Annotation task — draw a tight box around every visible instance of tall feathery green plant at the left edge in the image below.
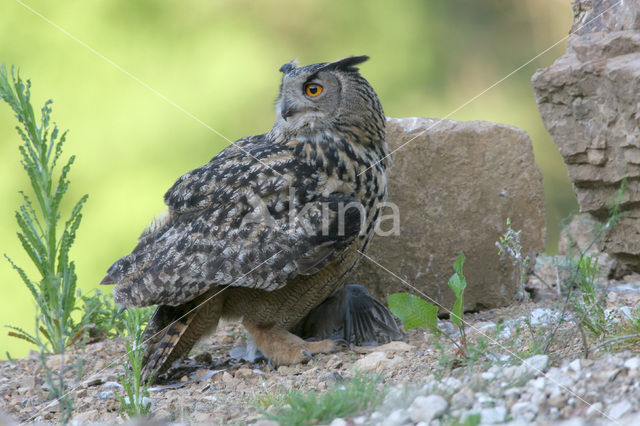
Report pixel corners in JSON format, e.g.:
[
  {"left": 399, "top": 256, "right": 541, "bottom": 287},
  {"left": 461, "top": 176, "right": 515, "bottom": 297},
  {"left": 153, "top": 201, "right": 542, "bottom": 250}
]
[{"left": 0, "top": 65, "right": 87, "bottom": 353}]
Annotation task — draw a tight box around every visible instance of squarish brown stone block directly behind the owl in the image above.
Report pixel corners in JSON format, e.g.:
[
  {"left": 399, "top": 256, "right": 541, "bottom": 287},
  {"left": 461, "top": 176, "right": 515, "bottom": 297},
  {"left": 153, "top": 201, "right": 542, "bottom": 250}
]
[{"left": 347, "top": 118, "right": 545, "bottom": 310}]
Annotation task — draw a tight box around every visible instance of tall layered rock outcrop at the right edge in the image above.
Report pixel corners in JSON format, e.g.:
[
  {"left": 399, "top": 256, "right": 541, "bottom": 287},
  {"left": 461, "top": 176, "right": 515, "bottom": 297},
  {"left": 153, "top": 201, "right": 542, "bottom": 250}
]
[{"left": 532, "top": 0, "right": 640, "bottom": 271}]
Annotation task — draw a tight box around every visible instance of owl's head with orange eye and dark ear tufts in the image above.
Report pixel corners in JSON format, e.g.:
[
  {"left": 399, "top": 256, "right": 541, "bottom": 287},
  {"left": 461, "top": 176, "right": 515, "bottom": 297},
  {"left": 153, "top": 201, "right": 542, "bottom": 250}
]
[{"left": 272, "top": 56, "right": 384, "bottom": 136}]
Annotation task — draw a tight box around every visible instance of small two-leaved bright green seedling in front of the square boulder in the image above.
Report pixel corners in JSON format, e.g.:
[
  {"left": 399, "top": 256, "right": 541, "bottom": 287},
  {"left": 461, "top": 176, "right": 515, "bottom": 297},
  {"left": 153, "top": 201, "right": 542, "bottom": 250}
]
[{"left": 387, "top": 253, "right": 469, "bottom": 358}]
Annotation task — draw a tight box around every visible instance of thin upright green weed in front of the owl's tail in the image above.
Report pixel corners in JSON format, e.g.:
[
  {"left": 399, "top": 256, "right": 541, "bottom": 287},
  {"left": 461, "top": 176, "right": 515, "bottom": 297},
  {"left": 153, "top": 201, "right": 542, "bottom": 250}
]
[{"left": 116, "top": 308, "right": 151, "bottom": 419}]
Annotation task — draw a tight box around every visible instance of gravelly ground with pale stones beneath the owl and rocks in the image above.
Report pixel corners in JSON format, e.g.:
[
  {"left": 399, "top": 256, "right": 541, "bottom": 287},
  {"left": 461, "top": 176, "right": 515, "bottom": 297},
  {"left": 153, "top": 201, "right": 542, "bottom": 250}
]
[{"left": 0, "top": 268, "right": 640, "bottom": 426}]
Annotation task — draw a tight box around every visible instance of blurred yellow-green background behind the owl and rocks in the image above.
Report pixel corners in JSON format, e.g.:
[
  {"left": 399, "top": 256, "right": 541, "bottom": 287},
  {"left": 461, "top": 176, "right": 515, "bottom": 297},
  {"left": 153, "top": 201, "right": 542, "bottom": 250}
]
[{"left": 0, "top": 0, "right": 576, "bottom": 358}]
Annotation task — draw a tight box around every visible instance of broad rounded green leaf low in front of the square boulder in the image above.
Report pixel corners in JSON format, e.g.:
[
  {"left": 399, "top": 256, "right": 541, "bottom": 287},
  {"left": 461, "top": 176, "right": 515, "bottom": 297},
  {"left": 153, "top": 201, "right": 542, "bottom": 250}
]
[{"left": 387, "top": 293, "right": 440, "bottom": 336}]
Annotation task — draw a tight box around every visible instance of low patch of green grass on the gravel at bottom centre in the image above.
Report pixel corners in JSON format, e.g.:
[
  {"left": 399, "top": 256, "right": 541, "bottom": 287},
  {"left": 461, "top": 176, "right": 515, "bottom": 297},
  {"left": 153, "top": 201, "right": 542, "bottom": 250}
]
[{"left": 257, "top": 373, "right": 386, "bottom": 426}]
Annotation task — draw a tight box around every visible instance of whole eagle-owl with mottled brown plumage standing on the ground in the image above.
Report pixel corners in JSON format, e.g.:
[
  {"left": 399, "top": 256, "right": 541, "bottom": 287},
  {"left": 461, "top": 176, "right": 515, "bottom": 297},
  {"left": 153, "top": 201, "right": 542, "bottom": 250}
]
[{"left": 102, "top": 57, "right": 388, "bottom": 382}]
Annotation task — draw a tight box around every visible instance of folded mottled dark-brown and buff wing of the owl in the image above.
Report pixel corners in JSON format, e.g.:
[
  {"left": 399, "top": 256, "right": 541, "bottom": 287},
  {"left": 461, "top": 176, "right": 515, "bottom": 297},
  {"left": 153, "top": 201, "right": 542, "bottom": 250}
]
[{"left": 102, "top": 136, "right": 361, "bottom": 306}]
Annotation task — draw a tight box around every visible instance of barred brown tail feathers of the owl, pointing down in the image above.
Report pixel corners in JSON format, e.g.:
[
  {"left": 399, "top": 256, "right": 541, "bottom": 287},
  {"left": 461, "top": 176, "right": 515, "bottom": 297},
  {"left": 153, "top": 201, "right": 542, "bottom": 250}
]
[{"left": 142, "top": 291, "right": 224, "bottom": 383}]
